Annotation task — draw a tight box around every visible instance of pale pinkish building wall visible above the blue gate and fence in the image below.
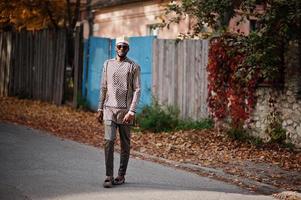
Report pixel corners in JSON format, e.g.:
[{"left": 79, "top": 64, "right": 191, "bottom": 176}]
[{"left": 94, "top": 1, "right": 189, "bottom": 39}]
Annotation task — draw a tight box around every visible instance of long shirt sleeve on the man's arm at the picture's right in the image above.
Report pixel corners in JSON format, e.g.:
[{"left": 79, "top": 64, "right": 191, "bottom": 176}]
[{"left": 130, "top": 64, "right": 141, "bottom": 112}]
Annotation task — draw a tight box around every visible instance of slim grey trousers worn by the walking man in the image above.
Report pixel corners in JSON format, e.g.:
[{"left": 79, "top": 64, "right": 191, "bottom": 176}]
[{"left": 104, "top": 121, "right": 131, "bottom": 176}]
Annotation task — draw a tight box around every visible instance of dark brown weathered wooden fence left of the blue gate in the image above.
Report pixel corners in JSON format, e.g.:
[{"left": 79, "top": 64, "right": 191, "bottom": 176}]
[{"left": 0, "top": 27, "right": 83, "bottom": 106}]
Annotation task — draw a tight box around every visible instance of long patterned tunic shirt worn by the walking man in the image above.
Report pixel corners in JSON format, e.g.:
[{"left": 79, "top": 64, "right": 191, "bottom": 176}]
[{"left": 98, "top": 58, "right": 141, "bottom": 124}]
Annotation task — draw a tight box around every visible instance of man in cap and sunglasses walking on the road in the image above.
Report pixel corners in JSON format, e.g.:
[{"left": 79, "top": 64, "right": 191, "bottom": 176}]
[{"left": 97, "top": 37, "right": 140, "bottom": 188}]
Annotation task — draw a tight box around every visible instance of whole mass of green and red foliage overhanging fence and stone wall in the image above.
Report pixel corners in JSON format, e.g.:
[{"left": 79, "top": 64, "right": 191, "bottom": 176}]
[{"left": 162, "top": 0, "right": 301, "bottom": 128}]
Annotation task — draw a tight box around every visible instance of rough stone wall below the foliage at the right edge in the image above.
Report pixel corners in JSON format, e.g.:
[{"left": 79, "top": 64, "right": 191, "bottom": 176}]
[{"left": 251, "top": 44, "right": 301, "bottom": 148}]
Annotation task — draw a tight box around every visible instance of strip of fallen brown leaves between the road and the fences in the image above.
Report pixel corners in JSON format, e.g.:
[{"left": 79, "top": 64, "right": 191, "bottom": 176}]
[{"left": 0, "top": 97, "right": 301, "bottom": 192}]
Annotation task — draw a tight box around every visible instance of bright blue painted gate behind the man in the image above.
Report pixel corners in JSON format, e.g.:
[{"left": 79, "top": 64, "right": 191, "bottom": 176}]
[{"left": 82, "top": 36, "right": 155, "bottom": 111}]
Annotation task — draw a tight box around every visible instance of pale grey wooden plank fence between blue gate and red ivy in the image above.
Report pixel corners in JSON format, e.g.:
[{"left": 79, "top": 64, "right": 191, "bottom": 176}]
[{"left": 152, "top": 39, "right": 208, "bottom": 120}]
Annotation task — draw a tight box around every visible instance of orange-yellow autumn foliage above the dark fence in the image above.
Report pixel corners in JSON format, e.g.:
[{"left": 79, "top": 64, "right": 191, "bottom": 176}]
[{"left": 0, "top": 0, "right": 81, "bottom": 31}]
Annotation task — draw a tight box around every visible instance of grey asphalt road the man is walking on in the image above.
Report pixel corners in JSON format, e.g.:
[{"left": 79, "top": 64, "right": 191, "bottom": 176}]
[{"left": 0, "top": 123, "right": 273, "bottom": 200}]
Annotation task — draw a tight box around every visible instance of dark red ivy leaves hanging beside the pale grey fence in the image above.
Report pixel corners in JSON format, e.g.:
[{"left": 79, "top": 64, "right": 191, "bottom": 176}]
[{"left": 207, "top": 36, "right": 257, "bottom": 126}]
